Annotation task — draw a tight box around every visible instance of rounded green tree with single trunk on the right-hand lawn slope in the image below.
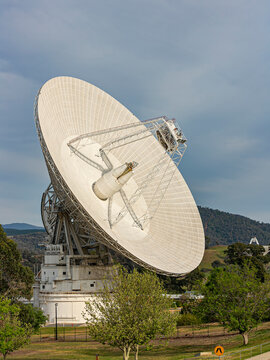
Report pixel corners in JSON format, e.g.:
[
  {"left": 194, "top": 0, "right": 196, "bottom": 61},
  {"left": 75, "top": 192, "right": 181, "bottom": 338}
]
[{"left": 198, "top": 265, "right": 270, "bottom": 345}]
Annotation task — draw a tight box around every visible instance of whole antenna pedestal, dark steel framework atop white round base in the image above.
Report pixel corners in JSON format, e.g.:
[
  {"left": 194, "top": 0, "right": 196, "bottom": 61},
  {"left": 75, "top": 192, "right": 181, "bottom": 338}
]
[{"left": 34, "top": 184, "right": 113, "bottom": 324}]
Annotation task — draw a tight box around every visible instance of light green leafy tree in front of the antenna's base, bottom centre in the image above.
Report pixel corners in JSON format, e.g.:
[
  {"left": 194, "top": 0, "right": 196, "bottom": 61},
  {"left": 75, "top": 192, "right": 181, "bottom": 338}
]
[{"left": 84, "top": 267, "right": 176, "bottom": 360}]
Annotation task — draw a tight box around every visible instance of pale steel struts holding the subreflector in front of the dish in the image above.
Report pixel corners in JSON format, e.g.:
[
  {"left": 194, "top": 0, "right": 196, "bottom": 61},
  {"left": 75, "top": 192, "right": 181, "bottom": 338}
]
[{"left": 68, "top": 116, "right": 187, "bottom": 229}]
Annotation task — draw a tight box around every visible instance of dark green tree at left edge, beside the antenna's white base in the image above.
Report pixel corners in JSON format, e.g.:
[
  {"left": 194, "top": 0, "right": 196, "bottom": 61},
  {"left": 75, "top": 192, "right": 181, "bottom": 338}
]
[{"left": 0, "top": 225, "right": 34, "bottom": 299}]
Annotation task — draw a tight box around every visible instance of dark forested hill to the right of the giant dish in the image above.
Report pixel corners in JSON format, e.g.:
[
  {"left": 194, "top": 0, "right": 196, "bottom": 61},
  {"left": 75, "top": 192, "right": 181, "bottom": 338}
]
[{"left": 198, "top": 206, "right": 270, "bottom": 246}]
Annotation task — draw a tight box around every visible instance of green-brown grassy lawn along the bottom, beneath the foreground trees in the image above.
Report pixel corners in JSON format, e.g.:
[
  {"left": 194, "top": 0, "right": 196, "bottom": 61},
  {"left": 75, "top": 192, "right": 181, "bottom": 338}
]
[{"left": 8, "top": 324, "right": 270, "bottom": 360}]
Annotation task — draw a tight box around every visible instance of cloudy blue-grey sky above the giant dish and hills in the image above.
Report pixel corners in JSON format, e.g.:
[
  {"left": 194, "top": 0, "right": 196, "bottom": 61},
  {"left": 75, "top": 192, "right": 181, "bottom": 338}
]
[{"left": 0, "top": 0, "right": 270, "bottom": 225}]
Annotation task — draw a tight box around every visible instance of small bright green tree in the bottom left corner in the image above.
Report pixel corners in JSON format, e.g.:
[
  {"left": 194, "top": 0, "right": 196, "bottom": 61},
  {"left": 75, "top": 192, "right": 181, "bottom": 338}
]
[{"left": 0, "top": 298, "right": 32, "bottom": 360}]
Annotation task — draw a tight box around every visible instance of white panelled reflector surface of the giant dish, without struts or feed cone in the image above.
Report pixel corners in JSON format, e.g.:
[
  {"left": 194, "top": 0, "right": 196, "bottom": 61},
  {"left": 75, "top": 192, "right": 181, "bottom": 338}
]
[{"left": 36, "top": 77, "right": 204, "bottom": 275}]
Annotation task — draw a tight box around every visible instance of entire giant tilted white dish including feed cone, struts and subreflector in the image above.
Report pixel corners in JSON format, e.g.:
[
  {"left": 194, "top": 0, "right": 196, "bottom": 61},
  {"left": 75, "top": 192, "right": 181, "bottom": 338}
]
[{"left": 35, "top": 77, "right": 204, "bottom": 276}]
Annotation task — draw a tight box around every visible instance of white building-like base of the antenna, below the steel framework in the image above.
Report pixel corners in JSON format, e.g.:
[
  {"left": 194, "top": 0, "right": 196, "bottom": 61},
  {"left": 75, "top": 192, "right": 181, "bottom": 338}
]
[{"left": 34, "top": 244, "right": 111, "bottom": 324}]
